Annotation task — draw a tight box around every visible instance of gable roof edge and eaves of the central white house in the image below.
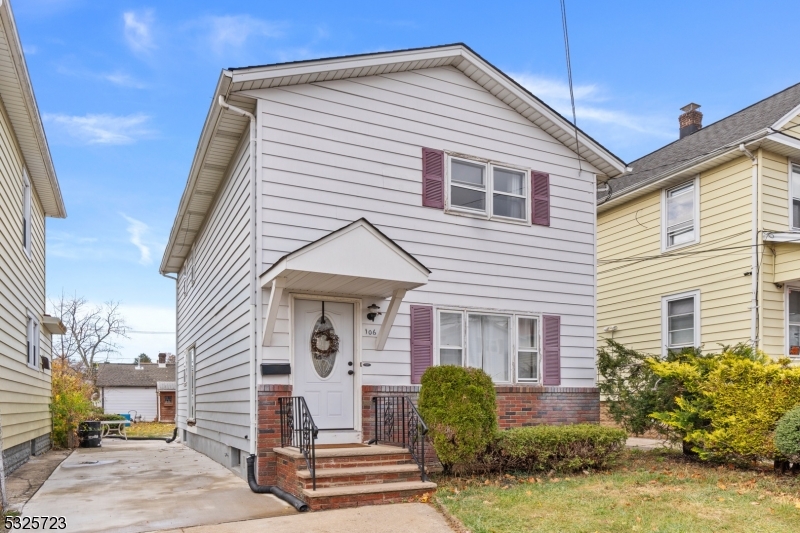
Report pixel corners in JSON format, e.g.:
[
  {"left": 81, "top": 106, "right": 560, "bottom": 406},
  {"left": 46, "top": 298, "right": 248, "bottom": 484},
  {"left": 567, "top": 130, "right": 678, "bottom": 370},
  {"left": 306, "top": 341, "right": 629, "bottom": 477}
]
[{"left": 160, "top": 43, "right": 625, "bottom": 273}]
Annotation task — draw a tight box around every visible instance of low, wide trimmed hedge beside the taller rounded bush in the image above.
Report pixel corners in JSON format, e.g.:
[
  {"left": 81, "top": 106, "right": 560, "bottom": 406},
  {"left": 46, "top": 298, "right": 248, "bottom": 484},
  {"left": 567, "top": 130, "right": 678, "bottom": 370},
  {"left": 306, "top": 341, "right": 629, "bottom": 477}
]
[{"left": 491, "top": 424, "right": 628, "bottom": 472}]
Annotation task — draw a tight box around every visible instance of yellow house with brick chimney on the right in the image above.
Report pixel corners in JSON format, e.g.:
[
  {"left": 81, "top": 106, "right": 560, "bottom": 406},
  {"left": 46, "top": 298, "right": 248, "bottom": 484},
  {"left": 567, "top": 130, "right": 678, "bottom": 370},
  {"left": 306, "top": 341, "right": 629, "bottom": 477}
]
[{"left": 597, "top": 89, "right": 800, "bottom": 358}]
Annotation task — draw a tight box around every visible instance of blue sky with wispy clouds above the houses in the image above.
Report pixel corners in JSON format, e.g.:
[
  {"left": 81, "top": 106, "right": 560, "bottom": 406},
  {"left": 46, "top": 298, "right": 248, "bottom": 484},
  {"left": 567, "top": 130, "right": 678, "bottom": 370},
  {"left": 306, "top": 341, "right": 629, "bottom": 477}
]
[{"left": 12, "top": 0, "right": 800, "bottom": 361}]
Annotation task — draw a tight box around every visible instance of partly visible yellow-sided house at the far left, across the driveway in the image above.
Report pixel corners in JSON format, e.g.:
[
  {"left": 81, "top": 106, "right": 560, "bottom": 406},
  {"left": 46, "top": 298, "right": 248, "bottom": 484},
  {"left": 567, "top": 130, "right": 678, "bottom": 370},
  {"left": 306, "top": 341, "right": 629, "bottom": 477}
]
[{"left": 0, "top": 1, "right": 66, "bottom": 476}]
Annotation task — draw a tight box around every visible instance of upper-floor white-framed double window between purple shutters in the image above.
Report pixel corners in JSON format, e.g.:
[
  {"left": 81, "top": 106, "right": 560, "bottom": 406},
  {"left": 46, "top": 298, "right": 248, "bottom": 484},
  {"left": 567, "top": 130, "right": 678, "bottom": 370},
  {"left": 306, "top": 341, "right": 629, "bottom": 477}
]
[{"left": 447, "top": 157, "right": 531, "bottom": 222}]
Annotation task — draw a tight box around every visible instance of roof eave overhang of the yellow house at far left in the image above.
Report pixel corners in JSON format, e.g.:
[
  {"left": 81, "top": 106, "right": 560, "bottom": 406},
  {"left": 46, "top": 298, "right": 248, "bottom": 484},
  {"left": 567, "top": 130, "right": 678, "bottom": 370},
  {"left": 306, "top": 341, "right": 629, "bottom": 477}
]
[{"left": 0, "top": 0, "right": 67, "bottom": 218}]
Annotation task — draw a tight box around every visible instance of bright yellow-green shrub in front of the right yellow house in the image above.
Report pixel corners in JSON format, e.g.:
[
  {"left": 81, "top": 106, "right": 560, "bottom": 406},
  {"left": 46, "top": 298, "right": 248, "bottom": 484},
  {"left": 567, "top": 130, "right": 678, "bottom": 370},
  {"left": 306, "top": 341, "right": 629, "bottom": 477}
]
[{"left": 650, "top": 347, "right": 800, "bottom": 461}]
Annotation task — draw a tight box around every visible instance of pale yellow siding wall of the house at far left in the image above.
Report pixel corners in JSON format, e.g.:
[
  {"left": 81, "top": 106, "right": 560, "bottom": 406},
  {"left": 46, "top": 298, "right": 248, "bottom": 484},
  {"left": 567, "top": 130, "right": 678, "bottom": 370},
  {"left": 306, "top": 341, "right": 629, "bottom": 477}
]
[{"left": 0, "top": 94, "right": 51, "bottom": 449}]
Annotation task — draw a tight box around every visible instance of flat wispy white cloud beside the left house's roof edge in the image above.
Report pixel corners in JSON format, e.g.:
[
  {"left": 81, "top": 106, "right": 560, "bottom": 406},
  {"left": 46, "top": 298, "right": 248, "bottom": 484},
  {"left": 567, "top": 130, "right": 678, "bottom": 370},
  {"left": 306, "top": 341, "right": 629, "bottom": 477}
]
[{"left": 43, "top": 113, "right": 154, "bottom": 144}]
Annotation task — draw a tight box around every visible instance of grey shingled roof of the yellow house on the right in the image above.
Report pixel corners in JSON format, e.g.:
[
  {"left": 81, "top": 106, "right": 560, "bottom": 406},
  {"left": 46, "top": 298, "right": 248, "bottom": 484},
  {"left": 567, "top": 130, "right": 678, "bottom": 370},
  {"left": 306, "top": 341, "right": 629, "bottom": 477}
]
[{"left": 598, "top": 84, "right": 800, "bottom": 211}]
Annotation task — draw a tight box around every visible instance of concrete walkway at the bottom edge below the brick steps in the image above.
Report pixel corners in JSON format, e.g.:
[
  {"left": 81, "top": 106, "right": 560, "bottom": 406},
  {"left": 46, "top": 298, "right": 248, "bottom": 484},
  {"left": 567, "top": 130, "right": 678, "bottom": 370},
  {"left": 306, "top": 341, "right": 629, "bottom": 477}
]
[{"left": 149, "top": 503, "right": 453, "bottom": 533}]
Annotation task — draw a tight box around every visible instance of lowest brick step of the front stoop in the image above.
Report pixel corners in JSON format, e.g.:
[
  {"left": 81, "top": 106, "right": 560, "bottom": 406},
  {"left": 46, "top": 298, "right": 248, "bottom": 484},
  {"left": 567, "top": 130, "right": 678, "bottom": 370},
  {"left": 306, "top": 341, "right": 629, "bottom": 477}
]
[{"left": 300, "top": 481, "right": 436, "bottom": 511}]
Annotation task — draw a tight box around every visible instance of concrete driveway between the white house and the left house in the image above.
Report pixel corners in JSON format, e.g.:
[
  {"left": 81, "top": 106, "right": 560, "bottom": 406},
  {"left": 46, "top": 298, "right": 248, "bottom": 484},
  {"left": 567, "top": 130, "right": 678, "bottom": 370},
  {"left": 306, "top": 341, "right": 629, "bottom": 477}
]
[{"left": 22, "top": 439, "right": 297, "bottom": 533}]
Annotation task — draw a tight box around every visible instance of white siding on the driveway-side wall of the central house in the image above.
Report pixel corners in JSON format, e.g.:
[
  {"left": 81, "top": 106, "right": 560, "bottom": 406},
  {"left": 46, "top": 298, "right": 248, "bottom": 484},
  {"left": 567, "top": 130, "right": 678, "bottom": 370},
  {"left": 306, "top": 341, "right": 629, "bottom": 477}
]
[{"left": 176, "top": 135, "right": 255, "bottom": 450}]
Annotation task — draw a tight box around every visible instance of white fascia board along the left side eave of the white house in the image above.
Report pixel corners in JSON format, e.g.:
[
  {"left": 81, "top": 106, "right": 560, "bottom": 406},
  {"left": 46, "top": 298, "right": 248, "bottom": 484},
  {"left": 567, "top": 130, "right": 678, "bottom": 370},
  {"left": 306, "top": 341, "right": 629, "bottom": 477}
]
[{"left": 159, "top": 70, "right": 231, "bottom": 274}]
